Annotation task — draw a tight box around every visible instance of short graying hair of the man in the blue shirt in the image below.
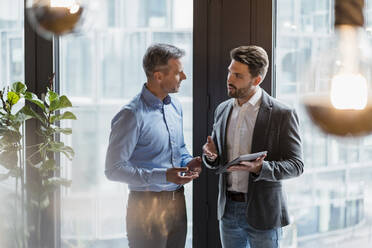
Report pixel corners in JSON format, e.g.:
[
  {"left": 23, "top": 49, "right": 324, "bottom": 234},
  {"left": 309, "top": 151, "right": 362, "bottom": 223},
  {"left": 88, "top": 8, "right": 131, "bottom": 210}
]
[{"left": 142, "top": 43, "right": 185, "bottom": 78}]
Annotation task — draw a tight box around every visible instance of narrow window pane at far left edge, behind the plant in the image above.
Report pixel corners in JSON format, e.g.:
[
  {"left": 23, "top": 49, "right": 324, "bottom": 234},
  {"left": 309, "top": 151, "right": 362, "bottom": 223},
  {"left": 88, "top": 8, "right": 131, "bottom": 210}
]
[{"left": 0, "top": 0, "right": 24, "bottom": 247}]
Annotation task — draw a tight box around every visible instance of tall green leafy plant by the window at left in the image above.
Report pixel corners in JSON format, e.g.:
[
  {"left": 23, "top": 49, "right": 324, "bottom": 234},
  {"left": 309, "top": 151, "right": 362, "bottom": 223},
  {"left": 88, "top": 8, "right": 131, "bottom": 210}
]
[{"left": 0, "top": 75, "right": 76, "bottom": 248}]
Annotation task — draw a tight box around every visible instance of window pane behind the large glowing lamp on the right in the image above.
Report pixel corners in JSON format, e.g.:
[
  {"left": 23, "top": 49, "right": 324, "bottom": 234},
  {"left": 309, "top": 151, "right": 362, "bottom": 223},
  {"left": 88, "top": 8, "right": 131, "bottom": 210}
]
[{"left": 275, "top": 0, "right": 372, "bottom": 248}]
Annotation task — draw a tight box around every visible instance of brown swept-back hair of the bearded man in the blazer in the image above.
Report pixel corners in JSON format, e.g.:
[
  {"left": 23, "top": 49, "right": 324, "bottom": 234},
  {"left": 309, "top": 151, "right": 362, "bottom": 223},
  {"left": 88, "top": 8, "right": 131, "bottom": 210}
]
[{"left": 230, "top": 46, "right": 269, "bottom": 80}]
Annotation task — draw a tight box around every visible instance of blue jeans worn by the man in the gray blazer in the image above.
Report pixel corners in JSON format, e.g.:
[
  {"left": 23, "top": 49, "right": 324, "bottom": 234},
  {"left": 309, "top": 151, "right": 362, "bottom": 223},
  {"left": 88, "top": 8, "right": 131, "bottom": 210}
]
[{"left": 220, "top": 199, "right": 282, "bottom": 248}]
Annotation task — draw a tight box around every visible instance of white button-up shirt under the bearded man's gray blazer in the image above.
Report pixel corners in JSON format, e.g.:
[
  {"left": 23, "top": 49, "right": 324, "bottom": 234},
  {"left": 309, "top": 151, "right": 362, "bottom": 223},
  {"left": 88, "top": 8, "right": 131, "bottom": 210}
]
[{"left": 227, "top": 87, "right": 262, "bottom": 193}]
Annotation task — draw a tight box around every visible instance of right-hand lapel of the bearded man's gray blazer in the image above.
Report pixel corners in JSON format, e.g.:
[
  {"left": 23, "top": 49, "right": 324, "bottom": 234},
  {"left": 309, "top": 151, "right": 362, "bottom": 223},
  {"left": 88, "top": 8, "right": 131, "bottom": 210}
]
[{"left": 251, "top": 90, "right": 272, "bottom": 153}]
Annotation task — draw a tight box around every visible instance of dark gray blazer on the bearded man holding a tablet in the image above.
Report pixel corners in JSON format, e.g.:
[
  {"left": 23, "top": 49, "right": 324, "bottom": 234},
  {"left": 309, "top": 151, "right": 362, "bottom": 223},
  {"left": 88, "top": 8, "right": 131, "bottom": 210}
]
[{"left": 203, "top": 91, "right": 304, "bottom": 230}]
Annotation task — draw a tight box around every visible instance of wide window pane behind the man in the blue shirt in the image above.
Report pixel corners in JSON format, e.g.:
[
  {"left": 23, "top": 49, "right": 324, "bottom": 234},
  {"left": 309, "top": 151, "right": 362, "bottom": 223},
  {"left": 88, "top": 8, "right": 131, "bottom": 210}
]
[{"left": 60, "top": 0, "right": 193, "bottom": 248}]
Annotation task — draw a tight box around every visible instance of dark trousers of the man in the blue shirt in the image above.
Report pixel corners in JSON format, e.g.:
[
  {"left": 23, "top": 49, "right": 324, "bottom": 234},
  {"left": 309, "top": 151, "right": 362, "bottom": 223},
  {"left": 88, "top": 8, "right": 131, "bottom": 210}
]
[{"left": 127, "top": 187, "right": 187, "bottom": 248}]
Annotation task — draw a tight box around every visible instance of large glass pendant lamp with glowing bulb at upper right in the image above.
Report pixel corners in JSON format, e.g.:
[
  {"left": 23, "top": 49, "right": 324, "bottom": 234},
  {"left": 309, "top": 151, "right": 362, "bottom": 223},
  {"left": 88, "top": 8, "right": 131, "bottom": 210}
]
[{"left": 302, "top": 0, "right": 372, "bottom": 137}]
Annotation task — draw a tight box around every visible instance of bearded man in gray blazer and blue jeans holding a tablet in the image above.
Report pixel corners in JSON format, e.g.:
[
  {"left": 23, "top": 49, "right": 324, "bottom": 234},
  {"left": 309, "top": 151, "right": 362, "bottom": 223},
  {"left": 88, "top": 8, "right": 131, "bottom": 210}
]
[{"left": 203, "top": 46, "right": 304, "bottom": 248}]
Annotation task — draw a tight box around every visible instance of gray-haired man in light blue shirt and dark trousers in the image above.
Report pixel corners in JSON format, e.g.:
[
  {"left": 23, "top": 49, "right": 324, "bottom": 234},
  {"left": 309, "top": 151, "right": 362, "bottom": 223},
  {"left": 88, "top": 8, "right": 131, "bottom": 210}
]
[{"left": 105, "top": 44, "right": 201, "bottom": 248}]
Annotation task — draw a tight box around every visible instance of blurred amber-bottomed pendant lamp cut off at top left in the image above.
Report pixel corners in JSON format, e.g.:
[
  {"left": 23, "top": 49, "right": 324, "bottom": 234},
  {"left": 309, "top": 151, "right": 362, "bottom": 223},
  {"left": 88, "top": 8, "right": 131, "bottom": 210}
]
[{"left": 26, "top": 0, "right": 86, "bottom": 39}]
